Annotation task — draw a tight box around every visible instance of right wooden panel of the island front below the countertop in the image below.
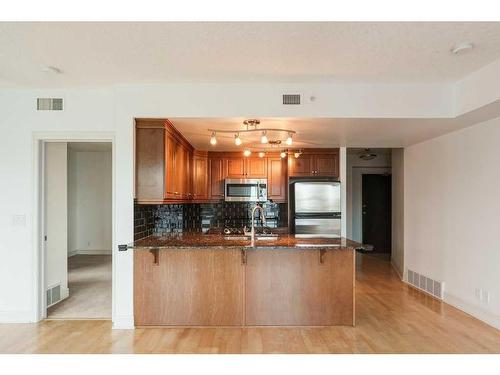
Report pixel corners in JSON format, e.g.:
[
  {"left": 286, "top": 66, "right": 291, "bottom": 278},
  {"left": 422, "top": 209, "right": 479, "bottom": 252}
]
[{"left": 245, "top": 249, "right": 354, "bottom": 326}]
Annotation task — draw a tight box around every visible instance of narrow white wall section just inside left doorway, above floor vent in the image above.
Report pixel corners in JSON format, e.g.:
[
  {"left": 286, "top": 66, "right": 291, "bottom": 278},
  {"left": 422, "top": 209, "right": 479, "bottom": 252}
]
[{"left": 45, "top": 142, "right": 68, "bottom": 298}]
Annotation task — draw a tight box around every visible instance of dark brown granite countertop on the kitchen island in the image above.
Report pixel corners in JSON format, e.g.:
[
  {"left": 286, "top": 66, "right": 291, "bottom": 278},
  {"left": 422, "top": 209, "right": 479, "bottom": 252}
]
[{"left": 127, "top": 233, "right": 362, "bottom": 250}]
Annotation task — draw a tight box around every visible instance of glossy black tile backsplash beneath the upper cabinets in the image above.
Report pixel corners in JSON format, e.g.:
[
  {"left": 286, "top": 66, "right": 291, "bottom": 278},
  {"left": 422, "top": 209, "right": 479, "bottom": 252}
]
[{"left": 134, "top": 202, "right": 288, "bottom": 240}]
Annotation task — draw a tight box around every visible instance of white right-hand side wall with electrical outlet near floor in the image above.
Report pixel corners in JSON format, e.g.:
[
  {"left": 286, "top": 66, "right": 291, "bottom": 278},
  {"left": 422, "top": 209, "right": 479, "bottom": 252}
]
[{"left": 404, "top": 118, "right": 500, "bottom": 328}]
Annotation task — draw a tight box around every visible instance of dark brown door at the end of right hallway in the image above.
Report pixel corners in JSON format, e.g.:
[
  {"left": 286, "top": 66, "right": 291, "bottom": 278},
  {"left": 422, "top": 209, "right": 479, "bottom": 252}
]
[{"left": 362, "top": 174, "right": 391, "bottom": 253}]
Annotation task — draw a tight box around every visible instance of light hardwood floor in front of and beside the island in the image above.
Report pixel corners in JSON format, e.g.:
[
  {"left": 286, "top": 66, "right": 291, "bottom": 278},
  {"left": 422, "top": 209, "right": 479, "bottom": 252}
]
[{"left": 0, "top": 255, "right": 500, "bottom": 353}]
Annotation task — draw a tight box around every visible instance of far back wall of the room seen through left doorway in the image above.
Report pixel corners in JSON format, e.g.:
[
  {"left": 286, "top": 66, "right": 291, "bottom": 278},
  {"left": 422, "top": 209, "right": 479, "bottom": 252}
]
[{"left": 68, "top": 147, "right": 112, "bottom": 255}]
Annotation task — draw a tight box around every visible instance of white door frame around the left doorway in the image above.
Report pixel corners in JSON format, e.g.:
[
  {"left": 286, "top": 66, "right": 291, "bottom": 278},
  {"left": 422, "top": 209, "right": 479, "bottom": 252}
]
[{"left": 32, "top": 131, "right": 116, "bottom": 322}]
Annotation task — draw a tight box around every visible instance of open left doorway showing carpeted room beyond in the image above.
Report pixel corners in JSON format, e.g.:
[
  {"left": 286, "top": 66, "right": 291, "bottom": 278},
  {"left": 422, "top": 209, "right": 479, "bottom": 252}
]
[{"left": 42, "top": 141, "right": 112, "bottom": 319}]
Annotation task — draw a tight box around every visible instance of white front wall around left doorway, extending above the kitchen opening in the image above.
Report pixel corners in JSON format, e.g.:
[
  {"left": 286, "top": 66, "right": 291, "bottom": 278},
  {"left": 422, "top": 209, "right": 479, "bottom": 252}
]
[{"left": 0, "top": 79, "right": 496, "bottom": 328}]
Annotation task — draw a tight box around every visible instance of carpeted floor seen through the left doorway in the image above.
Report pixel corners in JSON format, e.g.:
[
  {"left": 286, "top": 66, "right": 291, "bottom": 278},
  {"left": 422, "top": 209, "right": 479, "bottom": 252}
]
[{"left": 47, "top": 255, "right": 111, "bottom": 319}]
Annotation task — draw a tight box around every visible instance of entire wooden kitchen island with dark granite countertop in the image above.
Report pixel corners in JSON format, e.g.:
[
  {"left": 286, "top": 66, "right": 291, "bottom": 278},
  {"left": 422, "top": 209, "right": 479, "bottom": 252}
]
[{"left": 128, "top": 233, "right": 360, "bottom": 326}]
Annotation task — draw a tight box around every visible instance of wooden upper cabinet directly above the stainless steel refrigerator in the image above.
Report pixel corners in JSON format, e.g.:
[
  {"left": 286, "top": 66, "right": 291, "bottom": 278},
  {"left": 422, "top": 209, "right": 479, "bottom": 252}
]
[{"left": 288, "top": 149, "right": 339, "bottom": 177}]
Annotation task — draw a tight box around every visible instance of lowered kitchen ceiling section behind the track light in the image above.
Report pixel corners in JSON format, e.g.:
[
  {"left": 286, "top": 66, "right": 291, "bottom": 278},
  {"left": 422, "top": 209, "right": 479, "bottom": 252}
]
[{"left": 170, "top": 116, "right": 482, "bottom": 151}]
